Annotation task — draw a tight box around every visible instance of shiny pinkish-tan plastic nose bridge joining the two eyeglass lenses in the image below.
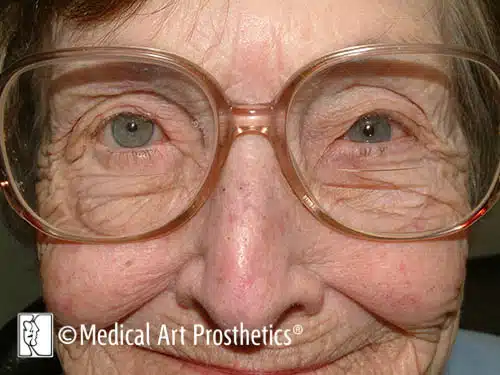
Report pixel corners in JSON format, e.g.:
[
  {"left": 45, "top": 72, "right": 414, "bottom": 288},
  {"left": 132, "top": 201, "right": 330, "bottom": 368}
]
[{"left": 230, "top": 104, "right": 275, "bottom": 141}]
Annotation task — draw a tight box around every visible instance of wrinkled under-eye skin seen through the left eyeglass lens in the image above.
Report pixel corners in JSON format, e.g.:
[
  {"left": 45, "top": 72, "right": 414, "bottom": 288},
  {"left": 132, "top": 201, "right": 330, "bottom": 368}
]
[{"left": 36, "top": 139, "right": 208, "bottom": 236}]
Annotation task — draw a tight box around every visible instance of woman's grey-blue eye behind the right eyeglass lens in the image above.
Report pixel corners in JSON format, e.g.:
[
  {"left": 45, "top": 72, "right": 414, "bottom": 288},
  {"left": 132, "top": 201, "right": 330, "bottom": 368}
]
[{"left": 344, "top": 114, "right": 392, "bottom": 143}]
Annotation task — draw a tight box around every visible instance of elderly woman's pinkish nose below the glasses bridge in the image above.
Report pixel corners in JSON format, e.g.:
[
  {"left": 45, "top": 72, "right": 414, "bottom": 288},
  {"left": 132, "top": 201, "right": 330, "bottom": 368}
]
[{"left": 178, "top": 134, "right": 323, "bottom": 329}]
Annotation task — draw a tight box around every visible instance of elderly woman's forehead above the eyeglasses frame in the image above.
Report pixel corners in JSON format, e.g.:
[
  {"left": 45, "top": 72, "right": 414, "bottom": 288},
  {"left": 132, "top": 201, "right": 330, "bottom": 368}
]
[{"left": 54, "top": 0, "right": 440, "bottom": 103}]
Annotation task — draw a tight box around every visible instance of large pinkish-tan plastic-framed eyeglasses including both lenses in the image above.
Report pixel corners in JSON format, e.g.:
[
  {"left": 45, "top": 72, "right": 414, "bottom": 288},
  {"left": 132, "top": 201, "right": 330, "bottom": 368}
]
[{"left": 0, "top": 45, "right": 500, "bottom": 243}]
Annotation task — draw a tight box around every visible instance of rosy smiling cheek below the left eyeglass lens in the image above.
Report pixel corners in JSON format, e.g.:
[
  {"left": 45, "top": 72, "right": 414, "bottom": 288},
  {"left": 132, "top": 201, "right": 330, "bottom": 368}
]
[{"left": 41, "top": 240, "right": 188, "bottom": 327}]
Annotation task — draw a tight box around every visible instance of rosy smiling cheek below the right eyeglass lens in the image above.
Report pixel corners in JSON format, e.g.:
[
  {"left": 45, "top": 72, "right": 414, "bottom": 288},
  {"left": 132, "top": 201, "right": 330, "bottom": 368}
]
[{"left": 310, "top": 240, "right": 467, "bottom": 328}]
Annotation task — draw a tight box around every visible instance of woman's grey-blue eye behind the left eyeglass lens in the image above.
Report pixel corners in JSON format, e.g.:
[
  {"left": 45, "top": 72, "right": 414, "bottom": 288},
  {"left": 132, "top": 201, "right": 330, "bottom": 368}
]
[{"left": 108, "top": 113, "right": 161, "bottom": 148}]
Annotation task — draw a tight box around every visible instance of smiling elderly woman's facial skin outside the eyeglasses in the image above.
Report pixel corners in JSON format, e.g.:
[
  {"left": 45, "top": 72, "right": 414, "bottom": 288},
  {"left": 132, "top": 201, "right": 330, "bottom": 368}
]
[{"left": 40, "top": 0, "right": 466, "bottom": 375}]
